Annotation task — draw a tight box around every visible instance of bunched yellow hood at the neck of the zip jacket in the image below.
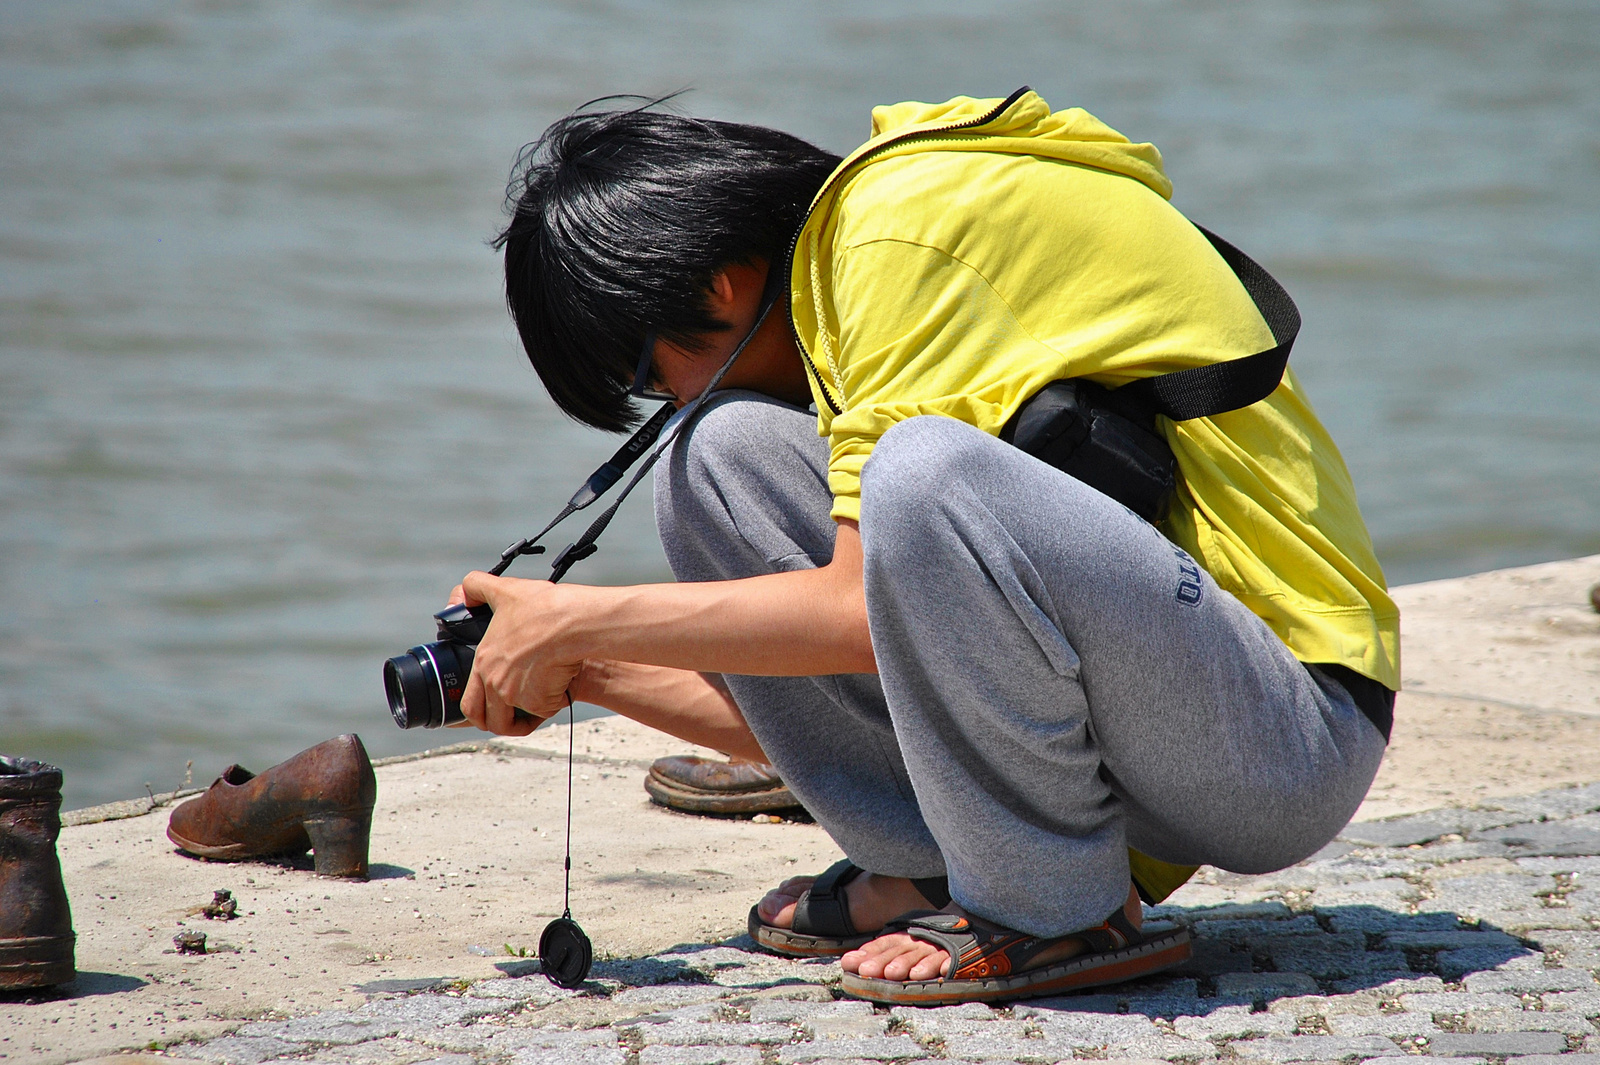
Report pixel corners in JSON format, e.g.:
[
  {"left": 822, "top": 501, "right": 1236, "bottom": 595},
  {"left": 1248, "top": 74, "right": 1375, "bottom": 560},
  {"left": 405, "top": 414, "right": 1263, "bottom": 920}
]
[{"left": 829, "top": 88, "right": 1173, "bottom": 200}]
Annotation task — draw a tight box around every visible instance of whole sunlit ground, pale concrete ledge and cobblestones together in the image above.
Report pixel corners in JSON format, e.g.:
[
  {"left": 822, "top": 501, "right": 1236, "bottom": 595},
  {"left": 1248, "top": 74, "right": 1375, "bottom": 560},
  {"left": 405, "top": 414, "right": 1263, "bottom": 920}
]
[{"left": 9, "top": 555, "right": 1600, "bottom": 1065}]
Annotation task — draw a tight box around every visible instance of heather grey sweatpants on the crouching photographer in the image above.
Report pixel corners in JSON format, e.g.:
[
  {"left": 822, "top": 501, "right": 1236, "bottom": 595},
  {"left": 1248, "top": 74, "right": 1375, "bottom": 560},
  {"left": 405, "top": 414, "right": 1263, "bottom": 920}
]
[{"left": 656, "top": 392, "right": 1384, "bottom": 935}]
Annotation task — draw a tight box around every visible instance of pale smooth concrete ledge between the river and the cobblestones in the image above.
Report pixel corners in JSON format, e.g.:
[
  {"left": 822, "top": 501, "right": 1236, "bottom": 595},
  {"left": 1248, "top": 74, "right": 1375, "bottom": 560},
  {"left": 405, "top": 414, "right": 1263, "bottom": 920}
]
[{"left": 0, "top": 556, "right": 1600, "bottom": 1065}]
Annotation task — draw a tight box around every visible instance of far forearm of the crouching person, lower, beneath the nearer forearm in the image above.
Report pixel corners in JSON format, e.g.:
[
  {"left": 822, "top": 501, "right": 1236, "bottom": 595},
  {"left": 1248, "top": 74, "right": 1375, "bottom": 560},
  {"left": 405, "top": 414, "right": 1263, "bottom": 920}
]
[{"left": 571, "top": 660, "right": 766, "bottom": 761}]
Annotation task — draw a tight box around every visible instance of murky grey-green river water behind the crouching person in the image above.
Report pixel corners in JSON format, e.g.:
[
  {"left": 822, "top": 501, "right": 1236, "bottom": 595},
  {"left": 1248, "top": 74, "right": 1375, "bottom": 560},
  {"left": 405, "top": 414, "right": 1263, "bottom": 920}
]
[{"left": 0, "top": 0, "right": 1600, "bottom": 806}]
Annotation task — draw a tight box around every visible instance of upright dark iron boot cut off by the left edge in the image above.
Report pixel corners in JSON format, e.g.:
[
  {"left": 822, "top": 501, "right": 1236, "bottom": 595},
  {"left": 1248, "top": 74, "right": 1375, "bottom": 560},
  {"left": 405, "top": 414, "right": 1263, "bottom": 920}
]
[{"left": 0, "top": 756, "right": 77, "bottom": 991}]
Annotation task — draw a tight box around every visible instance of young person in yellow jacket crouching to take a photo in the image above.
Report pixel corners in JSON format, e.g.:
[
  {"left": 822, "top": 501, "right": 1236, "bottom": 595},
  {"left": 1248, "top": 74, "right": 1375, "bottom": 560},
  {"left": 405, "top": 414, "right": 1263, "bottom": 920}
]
[{"left": 462, "top": 91, "right": 1398, "bottom": 1003}]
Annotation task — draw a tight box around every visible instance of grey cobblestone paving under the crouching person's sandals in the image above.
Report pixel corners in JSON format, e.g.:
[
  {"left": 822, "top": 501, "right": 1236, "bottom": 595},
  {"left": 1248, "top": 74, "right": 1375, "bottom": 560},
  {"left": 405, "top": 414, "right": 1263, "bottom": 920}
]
[{"left": 150, "top": 784, "right": 1600, "bottom": 1065}]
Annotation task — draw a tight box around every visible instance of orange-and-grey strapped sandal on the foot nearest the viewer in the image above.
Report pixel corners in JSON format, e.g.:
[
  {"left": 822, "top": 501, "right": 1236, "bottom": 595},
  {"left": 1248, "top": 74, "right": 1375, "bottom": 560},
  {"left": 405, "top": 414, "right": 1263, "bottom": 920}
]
[{"left": 843, "top": 907, "right": 1189, "bottom": 1006}]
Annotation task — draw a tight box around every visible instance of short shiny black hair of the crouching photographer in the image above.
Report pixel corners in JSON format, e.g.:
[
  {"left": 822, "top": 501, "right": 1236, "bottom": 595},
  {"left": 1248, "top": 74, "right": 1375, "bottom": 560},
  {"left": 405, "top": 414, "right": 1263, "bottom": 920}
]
[{"left": 493, "top": 98, "right": 840, "bottom": 432}]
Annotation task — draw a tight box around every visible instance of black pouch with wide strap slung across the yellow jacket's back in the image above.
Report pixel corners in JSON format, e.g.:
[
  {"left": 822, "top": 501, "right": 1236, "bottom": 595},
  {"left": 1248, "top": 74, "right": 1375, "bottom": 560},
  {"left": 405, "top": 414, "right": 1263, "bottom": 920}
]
[{"left": 1000, "top": 225, "right": 1301, "bottom": 523}]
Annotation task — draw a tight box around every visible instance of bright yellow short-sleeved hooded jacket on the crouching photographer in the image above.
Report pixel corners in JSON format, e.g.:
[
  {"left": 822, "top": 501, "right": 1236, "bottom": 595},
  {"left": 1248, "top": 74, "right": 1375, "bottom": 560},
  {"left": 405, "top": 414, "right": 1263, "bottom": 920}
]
[{"left": 789, "top": 91, "right": 1400, "bottom": 899}]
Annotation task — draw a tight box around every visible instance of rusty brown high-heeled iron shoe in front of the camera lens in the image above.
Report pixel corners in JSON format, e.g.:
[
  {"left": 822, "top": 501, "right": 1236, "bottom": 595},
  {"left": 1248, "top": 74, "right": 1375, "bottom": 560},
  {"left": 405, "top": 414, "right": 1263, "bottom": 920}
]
[{"left": 166, "top": 732, "right": 378, "bottom": 876}]
